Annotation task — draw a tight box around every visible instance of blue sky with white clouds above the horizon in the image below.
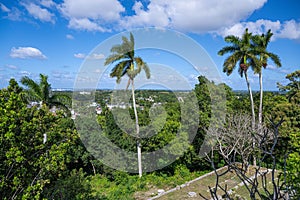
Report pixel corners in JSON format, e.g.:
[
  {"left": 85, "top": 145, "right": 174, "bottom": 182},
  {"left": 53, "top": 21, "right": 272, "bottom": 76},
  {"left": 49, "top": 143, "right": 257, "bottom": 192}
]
[{"left": 0, "top": 0, "right": 300, "bottom": 91}]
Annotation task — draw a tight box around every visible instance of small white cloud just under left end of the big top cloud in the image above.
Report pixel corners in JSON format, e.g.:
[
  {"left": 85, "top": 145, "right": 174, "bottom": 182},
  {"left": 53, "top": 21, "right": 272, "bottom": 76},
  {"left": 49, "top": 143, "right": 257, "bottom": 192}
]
[{"left": 68, "top": 18, "right": 107, "bottom": 32}]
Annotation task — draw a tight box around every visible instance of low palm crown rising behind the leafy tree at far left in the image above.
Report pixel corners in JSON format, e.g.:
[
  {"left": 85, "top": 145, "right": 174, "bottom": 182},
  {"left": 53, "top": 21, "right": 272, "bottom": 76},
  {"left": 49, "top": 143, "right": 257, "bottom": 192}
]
[{"left": 21, "top": 74, "right": 71, "bottom": 115}]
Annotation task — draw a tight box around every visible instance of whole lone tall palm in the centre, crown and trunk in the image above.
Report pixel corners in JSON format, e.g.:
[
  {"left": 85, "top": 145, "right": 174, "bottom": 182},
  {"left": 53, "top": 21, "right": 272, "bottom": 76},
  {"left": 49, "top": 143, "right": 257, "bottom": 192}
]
[{"left": 104, "top": 33, "right": 150, "bottom": 177}]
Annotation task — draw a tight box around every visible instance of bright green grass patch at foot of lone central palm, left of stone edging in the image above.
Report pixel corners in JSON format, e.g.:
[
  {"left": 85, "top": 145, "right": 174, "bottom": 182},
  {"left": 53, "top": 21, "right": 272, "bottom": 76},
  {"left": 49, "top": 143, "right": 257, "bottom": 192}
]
[{"left": 91, "top": 166, "right": 207, "bottom": 200}]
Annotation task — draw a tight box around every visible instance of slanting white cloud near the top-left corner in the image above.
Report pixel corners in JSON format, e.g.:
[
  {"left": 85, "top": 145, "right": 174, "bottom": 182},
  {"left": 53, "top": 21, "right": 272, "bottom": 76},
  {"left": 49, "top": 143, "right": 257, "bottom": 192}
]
[{"left": 23, "top": 3, "right": 54, "bottom": 23}]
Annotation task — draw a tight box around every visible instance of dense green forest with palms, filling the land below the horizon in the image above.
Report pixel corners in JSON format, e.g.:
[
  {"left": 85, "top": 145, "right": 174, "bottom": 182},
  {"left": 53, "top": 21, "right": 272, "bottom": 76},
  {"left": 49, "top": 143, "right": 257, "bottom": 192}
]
[{"left": 0, "top": 30, "right": 300, "bottom": 200}]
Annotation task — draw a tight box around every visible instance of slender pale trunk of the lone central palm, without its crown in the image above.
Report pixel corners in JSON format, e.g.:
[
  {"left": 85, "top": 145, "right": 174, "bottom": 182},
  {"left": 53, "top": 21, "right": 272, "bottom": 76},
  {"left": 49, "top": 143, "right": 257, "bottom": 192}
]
[{"left": 131, "top": 79, "right": 143, "bottom": 177}]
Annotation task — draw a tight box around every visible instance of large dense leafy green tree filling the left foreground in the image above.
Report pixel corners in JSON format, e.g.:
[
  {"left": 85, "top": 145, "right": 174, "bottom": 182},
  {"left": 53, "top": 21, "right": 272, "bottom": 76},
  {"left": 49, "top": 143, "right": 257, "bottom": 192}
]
[{"left": 0, "top": 79, "right": 78, "bottom": 199}]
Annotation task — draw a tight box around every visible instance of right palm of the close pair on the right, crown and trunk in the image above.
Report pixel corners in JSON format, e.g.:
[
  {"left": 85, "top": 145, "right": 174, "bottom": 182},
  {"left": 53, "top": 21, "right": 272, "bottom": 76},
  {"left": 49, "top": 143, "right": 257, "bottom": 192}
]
[{"left": 252, "top": 29, "right": 281, "bottom": 127}]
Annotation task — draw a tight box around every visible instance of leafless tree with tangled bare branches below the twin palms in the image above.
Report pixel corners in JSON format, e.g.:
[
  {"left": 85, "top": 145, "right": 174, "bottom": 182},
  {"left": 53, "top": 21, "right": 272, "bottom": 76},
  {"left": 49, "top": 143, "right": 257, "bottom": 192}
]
[{"left": 203, "top": 115, "right": 290, "bottom": 200}]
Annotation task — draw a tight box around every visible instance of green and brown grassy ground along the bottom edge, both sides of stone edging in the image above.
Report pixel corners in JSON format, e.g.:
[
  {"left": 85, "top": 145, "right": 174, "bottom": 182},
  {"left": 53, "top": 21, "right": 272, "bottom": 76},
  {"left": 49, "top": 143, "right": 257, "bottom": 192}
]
[{"left": 92, "top": 167, "right": 278, "bottom": 200}]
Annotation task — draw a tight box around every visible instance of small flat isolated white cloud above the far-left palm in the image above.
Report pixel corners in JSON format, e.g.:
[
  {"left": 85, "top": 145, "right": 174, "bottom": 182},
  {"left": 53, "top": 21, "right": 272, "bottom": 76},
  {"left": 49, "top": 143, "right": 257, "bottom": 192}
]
[{"left": 10, "top": 47, "right": 46, "bottom": 59}]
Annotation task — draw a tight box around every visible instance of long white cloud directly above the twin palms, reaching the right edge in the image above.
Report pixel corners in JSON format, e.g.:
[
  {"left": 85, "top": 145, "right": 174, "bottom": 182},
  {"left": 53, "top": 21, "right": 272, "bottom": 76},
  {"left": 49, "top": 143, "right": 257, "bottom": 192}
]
[{"left": 217, "top": 19, "right": 300, "bottom": 39}]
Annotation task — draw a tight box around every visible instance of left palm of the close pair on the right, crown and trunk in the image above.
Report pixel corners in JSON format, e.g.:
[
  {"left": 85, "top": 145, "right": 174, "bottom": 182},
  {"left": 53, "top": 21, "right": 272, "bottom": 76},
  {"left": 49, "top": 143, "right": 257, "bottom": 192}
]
[{"left": 218, "top": 29, "right": 258, "bottom": 130}]
